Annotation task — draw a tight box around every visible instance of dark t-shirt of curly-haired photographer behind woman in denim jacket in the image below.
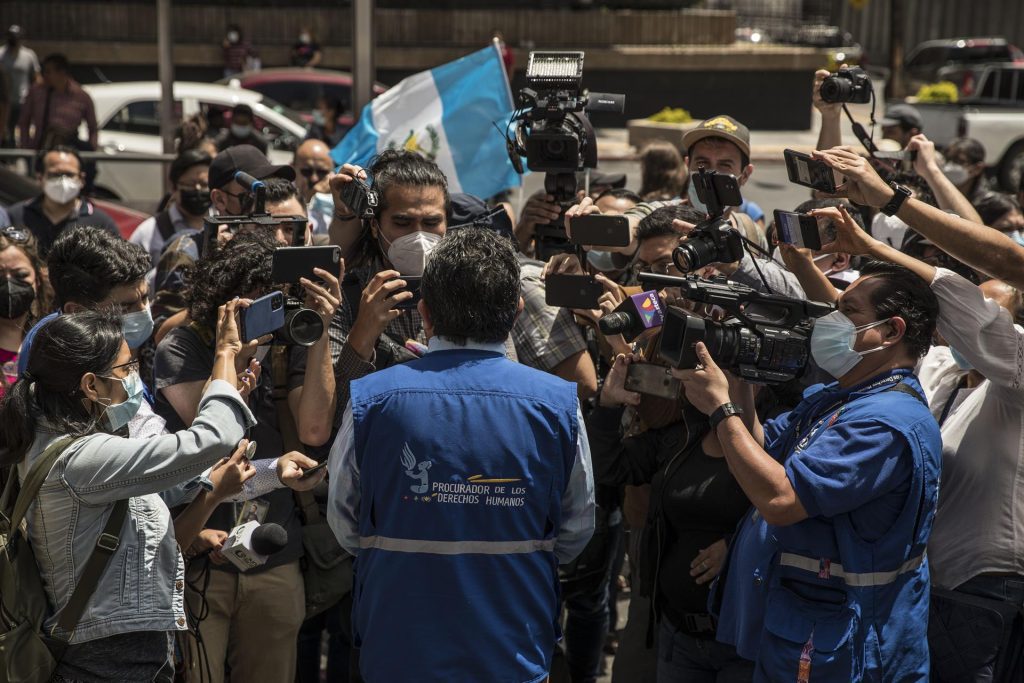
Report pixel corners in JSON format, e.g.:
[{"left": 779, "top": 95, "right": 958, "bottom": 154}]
[{"left": 154, "top": 327, "right": 302, "bottom": 573}]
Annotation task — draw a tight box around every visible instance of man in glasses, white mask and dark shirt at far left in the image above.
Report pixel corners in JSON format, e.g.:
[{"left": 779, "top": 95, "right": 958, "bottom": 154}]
[{"left": 9, "top": 146, "right": 121, "bottom": 258}]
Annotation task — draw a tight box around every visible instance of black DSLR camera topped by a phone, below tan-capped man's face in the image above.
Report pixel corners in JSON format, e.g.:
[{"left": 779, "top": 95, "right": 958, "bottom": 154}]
[{"left": 672, "top": 168, "right": 743, "bottom": 272}]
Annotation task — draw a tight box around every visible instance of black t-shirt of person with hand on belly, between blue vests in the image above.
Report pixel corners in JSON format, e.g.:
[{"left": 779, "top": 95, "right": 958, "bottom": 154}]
[{"left": 650, "top": 445, "right": 751, "bottom": 627}]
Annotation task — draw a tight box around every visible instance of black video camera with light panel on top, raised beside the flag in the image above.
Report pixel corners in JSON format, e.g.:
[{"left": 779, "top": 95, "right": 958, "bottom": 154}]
[{"left": 505, "top": 52, "right": 626, "bottom": 260}]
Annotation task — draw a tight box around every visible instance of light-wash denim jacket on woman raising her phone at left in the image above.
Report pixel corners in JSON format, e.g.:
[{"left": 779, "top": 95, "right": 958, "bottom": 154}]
[{"left": 18, "top": 380, "right": 255, "bottom": 643}]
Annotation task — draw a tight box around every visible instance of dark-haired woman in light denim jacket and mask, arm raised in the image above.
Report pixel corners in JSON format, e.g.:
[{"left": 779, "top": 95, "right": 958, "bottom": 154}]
[{"left": 0, "top": 300, "right": 254, "bottom": 681}]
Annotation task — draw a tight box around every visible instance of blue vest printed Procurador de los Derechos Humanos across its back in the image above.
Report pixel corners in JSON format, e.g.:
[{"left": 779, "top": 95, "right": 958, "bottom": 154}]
[{"left": 351, "top": 350, "right": 578, "bottom": 683}]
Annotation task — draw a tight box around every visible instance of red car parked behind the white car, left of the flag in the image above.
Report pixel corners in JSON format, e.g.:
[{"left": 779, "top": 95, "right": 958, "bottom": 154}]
[{"left": 217, "top": 68, "right": 387, "bottom": 128}]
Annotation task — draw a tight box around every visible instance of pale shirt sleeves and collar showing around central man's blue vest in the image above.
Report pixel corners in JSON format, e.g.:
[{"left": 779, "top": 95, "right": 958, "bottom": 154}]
[{"left": 327, "top": 337, "right": 595, "bottom": 563}]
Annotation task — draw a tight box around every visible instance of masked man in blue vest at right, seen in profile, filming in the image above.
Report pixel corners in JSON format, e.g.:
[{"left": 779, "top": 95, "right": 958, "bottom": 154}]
[{"left": 675, "top": 262, "right": 942, "bottom": 683}]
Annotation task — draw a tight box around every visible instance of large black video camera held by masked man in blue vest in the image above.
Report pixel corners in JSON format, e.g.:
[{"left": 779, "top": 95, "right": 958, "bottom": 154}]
[{"left": 640, "top": 272, "right": 835, "bottom": 384}]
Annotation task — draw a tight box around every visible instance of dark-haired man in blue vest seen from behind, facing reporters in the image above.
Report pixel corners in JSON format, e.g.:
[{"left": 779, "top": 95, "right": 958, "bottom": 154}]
[{"left": 328, "top": 227, "right": 594, "bottom": 683}]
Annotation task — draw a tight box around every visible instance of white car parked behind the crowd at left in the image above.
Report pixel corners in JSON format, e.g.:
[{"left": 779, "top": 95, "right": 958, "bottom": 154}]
[{"left": 81, "top": 81, "right": 306, "bottom": 213}]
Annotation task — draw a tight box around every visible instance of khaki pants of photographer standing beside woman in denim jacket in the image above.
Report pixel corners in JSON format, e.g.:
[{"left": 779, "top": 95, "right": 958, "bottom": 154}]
[{"left": 185, "top": 560, "right": 306, "bottom": 683}]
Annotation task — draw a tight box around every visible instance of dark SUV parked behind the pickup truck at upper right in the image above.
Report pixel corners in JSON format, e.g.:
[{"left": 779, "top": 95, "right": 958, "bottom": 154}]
[{"left": 905, "top": 38, "right": 1024, "bottom": 95}]
